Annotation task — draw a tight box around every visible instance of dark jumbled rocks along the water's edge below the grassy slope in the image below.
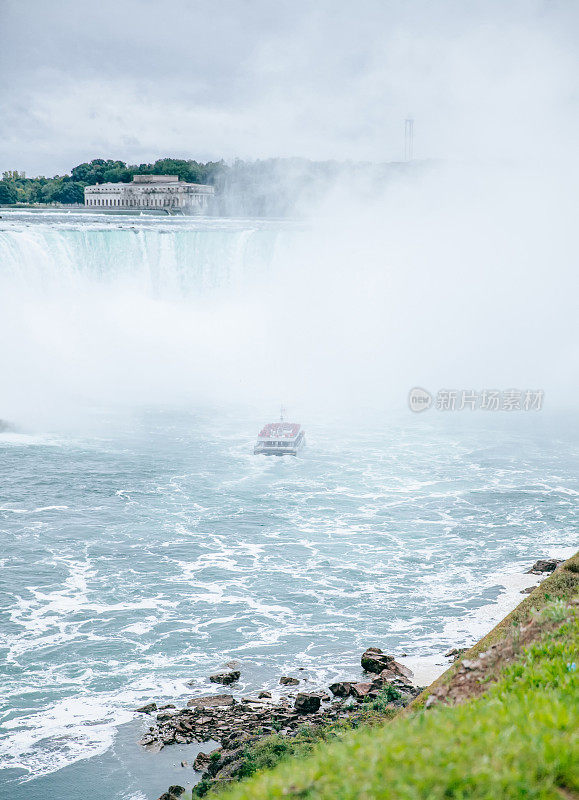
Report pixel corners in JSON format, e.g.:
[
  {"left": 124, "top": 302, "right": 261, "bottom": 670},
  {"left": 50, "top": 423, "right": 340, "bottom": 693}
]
[{"left": 145, "top": 559, "right": 562, "bottom": 800}]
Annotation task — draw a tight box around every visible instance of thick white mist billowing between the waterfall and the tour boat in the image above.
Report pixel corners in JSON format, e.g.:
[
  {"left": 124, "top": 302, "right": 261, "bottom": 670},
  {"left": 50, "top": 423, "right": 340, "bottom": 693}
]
[{"left": 0, "top": 155, "right": 577, "bottom": 419}]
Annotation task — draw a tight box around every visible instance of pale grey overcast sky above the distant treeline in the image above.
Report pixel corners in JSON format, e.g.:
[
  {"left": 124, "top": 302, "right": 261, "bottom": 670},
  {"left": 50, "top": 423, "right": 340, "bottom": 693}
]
[{"left": 0, "top": 0, "right": 579, "bottom": 175}]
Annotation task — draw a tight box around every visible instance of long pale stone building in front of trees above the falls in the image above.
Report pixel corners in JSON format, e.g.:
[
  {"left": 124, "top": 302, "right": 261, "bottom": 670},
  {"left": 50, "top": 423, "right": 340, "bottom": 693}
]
[{"left": 84, "top": 175, "right": 215, "bottom": 214}]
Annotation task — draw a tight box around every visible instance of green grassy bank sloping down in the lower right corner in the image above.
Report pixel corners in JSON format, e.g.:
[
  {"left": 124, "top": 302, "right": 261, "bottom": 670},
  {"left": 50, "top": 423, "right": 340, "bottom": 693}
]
[{"left": 185, "top": 554, "right": 579, "bottom": 800}]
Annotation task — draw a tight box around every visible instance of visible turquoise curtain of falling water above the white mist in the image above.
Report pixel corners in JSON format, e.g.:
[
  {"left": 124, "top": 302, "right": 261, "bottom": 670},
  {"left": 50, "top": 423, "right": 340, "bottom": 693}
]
[{"left": 0, "top": 222, "right": 280, "bottom": 297}]
